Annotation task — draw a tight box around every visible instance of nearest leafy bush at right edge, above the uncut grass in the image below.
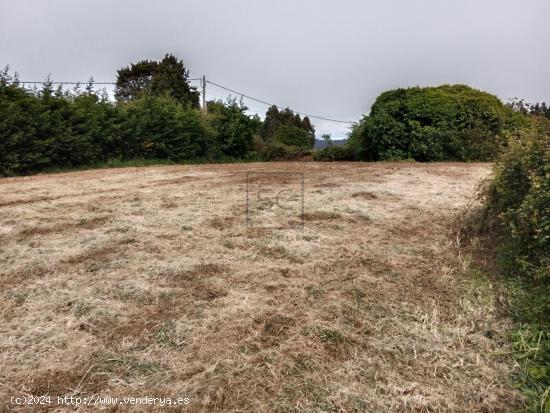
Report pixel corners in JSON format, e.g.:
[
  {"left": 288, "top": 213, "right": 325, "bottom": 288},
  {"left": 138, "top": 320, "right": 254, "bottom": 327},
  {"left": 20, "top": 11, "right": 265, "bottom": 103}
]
[{"left": 487, "top": 119, "right": 550, "bottom": 282}]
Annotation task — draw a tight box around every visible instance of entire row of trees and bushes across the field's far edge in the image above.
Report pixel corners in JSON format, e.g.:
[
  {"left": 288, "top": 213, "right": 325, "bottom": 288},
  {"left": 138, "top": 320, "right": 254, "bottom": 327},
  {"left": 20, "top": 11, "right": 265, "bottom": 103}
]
[{"left": 0, "top": 54, "right": 550, "bottom": 175}]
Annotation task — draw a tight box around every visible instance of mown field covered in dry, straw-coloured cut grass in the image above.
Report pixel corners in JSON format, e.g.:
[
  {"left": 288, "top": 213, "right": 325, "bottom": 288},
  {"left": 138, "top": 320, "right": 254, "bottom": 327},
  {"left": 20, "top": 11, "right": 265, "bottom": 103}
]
[{"left": 0, "top": 162, "right": 520, "bottom": 412}]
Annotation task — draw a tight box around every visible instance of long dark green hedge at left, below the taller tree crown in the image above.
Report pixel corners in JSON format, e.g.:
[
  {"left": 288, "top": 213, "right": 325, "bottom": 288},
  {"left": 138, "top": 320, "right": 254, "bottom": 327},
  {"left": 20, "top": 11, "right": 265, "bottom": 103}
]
[{"left": 0, "top": 71, "right": 261, "bottom": 175}]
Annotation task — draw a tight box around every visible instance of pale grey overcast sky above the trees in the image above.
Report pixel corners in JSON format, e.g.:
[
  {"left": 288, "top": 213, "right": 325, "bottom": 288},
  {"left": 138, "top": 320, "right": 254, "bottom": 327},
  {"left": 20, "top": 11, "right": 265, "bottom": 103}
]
[{"left": 0, "top": 0, "right": 550, "bottom": 138}]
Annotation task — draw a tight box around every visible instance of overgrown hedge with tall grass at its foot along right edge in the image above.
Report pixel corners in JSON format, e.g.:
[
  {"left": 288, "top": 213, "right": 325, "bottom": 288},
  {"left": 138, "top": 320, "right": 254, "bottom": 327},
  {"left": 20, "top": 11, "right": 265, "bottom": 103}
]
[{"left": 483, "top": 117, "right": 550, "bottom": 412}]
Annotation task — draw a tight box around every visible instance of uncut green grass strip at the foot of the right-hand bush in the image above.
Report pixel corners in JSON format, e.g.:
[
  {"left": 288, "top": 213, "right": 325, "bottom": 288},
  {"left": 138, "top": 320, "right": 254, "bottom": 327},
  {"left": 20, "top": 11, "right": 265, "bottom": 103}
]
[{"left": 459, "top": 208, "right": 550, "bottom": 413}]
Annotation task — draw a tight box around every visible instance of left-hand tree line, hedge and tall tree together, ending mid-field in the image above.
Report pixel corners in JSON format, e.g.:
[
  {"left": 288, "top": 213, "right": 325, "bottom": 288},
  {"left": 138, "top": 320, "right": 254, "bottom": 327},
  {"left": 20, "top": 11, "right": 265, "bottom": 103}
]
[{"left": 0, "top": 55, "right": 315, "bottom": 175}]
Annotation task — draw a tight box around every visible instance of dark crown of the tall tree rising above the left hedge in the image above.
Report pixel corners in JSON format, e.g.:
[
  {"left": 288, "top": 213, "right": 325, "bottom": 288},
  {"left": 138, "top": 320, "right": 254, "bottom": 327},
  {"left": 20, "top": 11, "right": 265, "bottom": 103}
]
[{"left": 115, "top": 54, "right": 199, "bottom": 108}]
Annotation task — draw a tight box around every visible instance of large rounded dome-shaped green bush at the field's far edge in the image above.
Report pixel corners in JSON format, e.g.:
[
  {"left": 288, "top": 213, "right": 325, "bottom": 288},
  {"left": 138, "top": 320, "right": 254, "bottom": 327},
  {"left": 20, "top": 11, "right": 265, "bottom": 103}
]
[{"left": 350, "top": 85, "right": 524, "bottom": 161}]
